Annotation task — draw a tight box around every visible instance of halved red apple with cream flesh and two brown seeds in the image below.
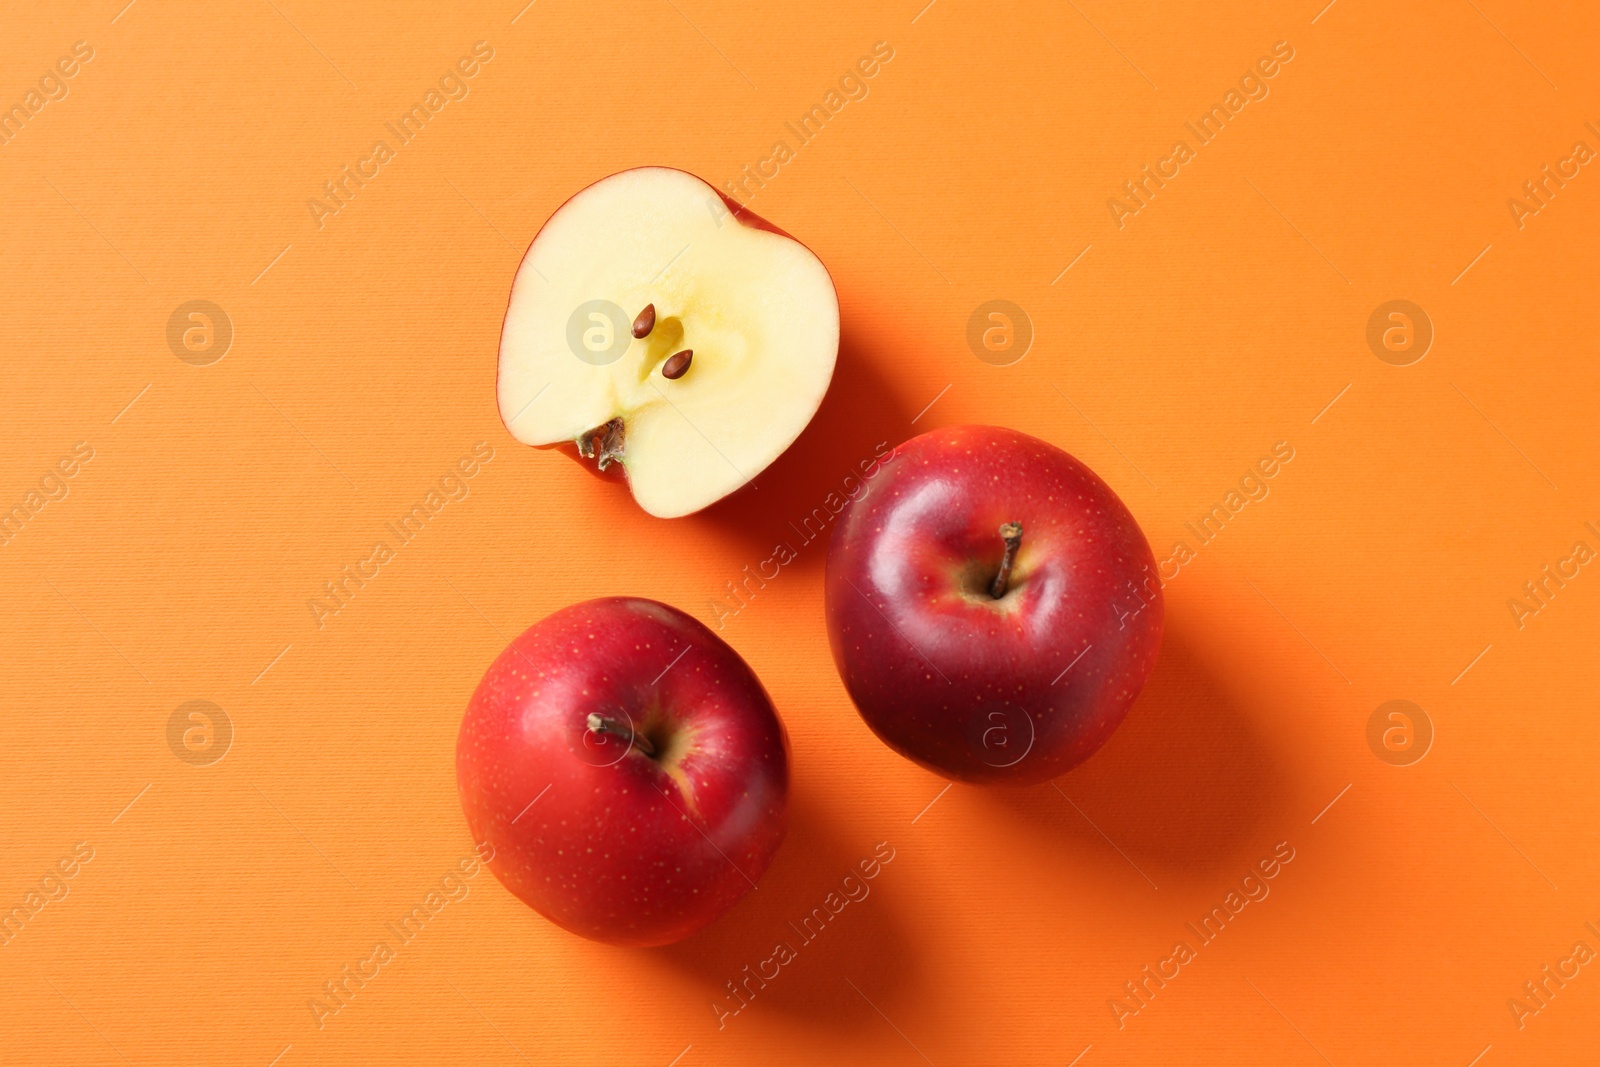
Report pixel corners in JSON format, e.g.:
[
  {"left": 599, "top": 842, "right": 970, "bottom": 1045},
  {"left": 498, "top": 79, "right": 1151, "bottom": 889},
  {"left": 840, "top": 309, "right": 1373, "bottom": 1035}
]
[{"left": 499, "top": 166, "right": 838, "bottom": 518}]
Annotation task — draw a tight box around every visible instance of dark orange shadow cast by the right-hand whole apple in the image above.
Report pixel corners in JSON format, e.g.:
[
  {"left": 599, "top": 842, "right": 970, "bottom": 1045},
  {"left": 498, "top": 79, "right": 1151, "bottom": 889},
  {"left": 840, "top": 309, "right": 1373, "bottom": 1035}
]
[{"left": 978, "top": 614, "right": 1286, "bottom": 888}]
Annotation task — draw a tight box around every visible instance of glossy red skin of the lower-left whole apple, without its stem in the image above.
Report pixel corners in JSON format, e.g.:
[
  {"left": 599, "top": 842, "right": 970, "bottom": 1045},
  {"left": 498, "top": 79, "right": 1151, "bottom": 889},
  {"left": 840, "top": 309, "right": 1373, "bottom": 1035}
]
[{"left": 456, "top": 597, "right": 789, "bottom": 945}]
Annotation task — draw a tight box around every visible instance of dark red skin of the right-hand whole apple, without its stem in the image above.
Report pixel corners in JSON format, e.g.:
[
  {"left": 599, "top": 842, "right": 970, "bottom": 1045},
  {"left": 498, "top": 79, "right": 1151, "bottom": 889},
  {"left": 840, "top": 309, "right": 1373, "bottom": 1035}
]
[{"left": 826, "top": 426, "right": 1162, "bottom": 785}]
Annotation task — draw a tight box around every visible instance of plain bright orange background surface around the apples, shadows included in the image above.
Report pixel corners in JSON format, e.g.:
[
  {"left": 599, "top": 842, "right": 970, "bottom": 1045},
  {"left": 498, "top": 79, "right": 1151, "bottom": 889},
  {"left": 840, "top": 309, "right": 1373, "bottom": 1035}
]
[{"left": 0, "top": 0, "right": 1600, "bottom": 1067}]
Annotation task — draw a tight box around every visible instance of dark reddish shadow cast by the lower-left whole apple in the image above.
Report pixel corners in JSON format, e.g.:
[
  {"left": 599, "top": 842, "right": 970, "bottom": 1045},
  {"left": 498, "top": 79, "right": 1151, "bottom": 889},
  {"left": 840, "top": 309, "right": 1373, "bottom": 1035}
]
[{"left": 638, "top": 792, "right": 915, "bottom": 1032}]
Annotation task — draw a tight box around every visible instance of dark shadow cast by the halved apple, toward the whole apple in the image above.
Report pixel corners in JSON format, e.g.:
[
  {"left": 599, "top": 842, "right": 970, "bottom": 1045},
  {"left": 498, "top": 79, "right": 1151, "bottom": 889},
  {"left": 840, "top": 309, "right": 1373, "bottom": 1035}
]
[{"left": 675, "top": 323, "right": 910, "bottom": 566}]
